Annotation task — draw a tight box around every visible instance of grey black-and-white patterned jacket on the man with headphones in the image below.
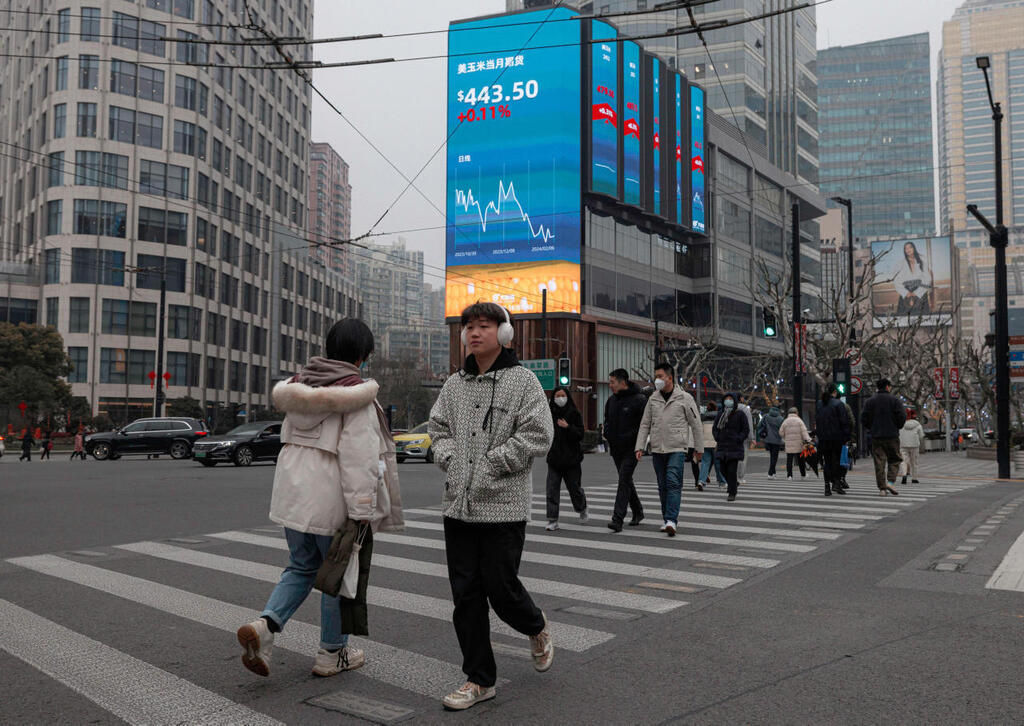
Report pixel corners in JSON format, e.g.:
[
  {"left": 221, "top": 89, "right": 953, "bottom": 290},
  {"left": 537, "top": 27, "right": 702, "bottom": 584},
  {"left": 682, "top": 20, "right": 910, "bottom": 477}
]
[{"left": 428, "top": 348, "right": 554, "bottom": 522}]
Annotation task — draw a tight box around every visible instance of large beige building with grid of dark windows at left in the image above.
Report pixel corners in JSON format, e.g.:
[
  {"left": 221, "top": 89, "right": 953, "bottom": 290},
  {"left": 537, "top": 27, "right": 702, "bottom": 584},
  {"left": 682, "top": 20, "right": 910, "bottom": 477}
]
[{"left": 0, "top": 0, "right": 358, "bottom": 422}]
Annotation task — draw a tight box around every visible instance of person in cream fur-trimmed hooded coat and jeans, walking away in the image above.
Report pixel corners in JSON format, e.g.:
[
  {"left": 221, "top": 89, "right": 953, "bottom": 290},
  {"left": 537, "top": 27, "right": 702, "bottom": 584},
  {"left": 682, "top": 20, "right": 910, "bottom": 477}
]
[{"left": 237, "top": 317, "right": 403, "bottom": 677}]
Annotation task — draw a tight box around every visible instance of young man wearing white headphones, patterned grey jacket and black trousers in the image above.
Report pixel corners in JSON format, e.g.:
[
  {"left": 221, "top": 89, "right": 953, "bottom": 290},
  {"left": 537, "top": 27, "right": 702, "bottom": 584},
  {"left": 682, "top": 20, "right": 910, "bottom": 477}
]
[{"left": 428, "top": 302, "right": 554, "bottom": 711}]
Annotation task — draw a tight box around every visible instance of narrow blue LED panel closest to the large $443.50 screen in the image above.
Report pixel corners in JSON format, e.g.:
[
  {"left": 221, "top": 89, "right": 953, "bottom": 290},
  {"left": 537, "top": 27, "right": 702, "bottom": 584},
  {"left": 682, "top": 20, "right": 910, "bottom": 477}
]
[{"left": 590, "top": 20, "right": 618, "bottom": 197}]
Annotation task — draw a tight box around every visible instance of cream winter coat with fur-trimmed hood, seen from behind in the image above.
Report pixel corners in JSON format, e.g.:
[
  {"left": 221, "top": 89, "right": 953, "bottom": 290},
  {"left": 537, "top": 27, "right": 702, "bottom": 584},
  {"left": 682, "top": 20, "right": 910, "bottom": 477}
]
[{"left": 270, "top": 357, "right": 403, "bottom": 536}]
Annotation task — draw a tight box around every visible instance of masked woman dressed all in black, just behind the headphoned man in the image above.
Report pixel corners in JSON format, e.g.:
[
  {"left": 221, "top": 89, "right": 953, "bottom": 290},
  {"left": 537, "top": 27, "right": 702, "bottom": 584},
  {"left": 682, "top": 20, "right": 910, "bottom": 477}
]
[{"left": 545, "top": 386, "right": 589, "bottom": 531}]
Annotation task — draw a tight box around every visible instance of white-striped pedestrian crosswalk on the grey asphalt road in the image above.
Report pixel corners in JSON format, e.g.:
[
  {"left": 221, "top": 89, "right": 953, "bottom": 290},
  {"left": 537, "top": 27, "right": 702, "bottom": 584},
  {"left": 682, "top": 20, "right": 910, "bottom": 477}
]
[{"left": 0, "top": 478, "right": 984, "bottom": 724}]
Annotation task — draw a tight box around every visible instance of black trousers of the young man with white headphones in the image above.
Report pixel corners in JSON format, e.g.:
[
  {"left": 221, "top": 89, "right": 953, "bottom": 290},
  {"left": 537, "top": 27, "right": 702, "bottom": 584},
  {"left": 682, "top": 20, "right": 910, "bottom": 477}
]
[{"left": 444, "top": 517, "right": 544, "bottom": 688}]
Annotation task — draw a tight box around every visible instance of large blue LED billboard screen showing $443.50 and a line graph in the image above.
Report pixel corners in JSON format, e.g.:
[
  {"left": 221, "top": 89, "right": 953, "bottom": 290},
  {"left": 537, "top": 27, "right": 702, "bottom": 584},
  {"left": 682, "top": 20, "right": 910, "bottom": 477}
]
[{"left": 445, "top": 8, "right": 582, "bottom": 316}]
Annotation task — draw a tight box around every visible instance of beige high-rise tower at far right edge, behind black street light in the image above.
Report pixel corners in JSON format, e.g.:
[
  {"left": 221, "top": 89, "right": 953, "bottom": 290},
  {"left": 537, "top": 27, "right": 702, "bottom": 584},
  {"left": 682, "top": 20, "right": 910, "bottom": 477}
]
[{"left": 936, "top": 0, "right": 1024, "bottom": 340}]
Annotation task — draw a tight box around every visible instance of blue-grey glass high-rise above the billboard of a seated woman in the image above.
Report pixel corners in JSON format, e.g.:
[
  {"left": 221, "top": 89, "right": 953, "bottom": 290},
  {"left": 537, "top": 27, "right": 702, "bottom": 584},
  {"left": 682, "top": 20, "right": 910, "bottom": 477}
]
[{"left": 818, "top": 33, "right": 935, "bottom": 240}]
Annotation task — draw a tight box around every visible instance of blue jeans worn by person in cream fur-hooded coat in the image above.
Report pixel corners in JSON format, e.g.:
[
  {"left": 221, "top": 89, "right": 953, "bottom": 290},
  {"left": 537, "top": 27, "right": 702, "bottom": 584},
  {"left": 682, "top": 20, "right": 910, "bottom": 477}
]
[{"left": 260, "top": 527, "right": 348, "bottom": 650}]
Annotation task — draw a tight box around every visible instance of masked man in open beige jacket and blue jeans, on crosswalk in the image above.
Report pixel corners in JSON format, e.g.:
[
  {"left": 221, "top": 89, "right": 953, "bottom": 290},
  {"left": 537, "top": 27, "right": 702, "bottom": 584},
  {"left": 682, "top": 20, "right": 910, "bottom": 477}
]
[{"left": 636, "top": 364, "right": 705, "bottom": 537}]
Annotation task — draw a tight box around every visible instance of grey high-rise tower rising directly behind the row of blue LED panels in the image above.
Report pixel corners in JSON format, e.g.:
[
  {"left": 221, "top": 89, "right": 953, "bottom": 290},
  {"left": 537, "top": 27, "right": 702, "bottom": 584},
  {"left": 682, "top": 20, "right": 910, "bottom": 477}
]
[{"left": 506, "top": 0, "right": 818, "bottom": 184}]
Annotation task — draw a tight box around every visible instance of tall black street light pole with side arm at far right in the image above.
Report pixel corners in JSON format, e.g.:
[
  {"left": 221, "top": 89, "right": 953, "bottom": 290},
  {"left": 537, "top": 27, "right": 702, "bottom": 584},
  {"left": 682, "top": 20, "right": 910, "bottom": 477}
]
[{"left": 967, "top": 55, "right": 1010, "bottom": 479}]
